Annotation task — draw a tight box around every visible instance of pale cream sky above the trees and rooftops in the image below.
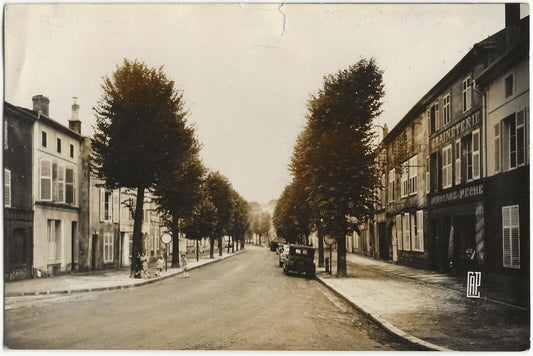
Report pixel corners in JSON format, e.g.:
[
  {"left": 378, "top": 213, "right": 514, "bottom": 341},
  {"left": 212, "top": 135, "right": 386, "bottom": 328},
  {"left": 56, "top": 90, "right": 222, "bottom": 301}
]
[{"left": 4, "top": 3, "right": 528, "bottom": 204}]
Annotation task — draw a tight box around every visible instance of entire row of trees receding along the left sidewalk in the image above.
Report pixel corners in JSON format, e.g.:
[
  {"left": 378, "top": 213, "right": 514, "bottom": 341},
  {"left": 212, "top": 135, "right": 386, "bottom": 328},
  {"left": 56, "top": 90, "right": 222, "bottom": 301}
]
[{"left": 91, "top": 60, "right": 249, "bottom": 277}]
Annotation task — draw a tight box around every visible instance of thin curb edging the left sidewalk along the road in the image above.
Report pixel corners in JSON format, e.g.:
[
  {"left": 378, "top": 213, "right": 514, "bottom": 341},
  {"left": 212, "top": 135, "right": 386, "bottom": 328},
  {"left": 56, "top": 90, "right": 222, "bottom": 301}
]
[{"left": 4, "top": 250, "right": 246, "bottom": 298}]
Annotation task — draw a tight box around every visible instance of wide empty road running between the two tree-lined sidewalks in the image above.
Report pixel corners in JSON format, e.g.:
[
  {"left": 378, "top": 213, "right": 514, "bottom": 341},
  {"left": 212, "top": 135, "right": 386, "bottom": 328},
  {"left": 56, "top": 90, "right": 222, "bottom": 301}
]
[{"left": 4, "top": 246, "right": 407, "bottom": 351}]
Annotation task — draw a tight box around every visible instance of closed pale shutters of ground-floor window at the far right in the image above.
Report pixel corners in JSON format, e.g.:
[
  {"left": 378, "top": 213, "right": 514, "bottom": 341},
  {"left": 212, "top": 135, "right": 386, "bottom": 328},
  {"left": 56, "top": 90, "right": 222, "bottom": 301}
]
[{"left": 502, "top": 205, "right": 520, "bottom": 268}]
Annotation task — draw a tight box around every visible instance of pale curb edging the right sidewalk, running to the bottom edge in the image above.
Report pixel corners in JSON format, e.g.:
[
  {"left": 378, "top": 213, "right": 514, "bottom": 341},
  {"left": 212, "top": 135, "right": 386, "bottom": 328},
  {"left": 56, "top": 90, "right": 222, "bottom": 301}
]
[{"left": 316, "top": 276, "right": 455, "bottom": 352}]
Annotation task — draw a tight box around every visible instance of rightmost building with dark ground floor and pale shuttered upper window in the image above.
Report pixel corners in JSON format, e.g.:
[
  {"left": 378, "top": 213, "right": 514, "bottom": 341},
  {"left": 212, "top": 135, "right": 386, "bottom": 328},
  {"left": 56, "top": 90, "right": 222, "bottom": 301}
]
[{"left": 476, "top": 8, "right": 530, "bottom": 286}]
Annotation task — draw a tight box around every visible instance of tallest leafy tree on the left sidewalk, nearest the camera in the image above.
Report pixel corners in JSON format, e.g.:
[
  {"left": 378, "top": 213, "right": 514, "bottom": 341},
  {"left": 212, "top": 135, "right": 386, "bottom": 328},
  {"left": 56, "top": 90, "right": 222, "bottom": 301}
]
[{"left": 91, "top": 59, "right": 189, "bottom": 277}]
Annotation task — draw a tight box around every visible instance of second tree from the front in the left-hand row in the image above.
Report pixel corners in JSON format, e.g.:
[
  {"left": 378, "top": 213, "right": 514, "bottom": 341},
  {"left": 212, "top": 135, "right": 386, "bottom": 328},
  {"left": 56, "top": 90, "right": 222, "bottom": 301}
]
[{"left": 154, "top": 139, "right": 206, "bottom": 267}]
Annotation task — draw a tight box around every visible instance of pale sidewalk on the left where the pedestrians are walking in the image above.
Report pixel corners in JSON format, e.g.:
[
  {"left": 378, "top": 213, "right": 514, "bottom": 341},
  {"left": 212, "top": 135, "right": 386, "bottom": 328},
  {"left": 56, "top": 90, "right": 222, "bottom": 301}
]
[{"left": 4, "top": 250, "right": 245, "bottom": 298}]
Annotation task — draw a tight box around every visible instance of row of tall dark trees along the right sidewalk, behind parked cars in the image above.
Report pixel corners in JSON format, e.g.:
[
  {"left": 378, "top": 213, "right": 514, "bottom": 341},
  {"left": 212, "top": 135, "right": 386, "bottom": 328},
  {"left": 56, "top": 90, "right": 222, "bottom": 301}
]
[{"left": 273, "top": 59, "right": 384, "bottom": 277}]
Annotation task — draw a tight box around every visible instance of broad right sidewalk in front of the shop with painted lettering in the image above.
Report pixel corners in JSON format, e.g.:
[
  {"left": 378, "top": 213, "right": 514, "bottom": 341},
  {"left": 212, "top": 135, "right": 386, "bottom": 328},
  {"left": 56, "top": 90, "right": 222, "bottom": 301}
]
[{"left": 317, "top": 254, "right": 530, "bottom": 351}]
